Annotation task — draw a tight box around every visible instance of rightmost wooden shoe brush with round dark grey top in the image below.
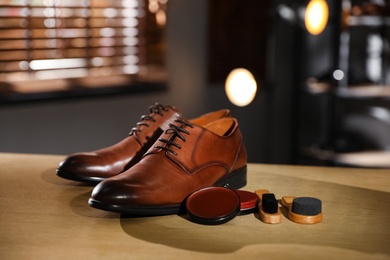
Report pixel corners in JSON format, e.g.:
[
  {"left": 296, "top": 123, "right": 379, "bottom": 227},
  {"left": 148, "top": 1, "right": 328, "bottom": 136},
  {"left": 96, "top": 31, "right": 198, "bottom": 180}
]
[{"left": 282, "top": 196, "right": 322, "bottom": 224}]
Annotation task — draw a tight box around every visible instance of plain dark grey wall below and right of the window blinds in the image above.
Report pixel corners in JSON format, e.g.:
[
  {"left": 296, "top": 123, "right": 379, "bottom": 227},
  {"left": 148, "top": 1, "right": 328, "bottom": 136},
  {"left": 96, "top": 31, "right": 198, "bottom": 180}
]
[{"left": 0, "top": 0, "right": 265, "bottom": 162}]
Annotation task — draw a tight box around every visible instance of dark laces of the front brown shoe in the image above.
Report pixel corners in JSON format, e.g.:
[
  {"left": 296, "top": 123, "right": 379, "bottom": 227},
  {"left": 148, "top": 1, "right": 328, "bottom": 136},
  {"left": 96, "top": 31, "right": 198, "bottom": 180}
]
[{"left": 154, "top": 118, "right": 194, "bottom": 155}]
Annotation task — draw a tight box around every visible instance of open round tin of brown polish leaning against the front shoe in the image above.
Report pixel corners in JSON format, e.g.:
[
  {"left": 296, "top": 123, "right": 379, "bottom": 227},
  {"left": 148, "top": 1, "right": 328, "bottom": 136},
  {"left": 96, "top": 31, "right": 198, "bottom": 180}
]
[{"left": 185, "top": 187, "right": 240, "bottom": 225}]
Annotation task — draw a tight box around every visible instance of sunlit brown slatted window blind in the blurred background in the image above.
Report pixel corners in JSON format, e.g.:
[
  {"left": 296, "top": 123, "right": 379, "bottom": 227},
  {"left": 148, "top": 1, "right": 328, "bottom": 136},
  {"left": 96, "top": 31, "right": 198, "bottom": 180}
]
[{"left": 0, "top": 0, "right": 166, "bottom": 95}]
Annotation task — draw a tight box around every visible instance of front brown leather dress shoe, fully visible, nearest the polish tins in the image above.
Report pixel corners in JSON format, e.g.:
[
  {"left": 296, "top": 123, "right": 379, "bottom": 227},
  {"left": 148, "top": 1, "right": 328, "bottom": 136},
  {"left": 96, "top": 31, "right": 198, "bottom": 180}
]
[{"left": 88, "top": 117, "right": 247, "bottom": 215}]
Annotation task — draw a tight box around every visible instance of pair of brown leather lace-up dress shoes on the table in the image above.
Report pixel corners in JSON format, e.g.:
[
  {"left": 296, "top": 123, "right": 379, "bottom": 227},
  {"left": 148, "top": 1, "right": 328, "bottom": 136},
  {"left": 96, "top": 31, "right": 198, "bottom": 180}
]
[{"left": 57, "top": 104, "right": 247, "bottom": 215}]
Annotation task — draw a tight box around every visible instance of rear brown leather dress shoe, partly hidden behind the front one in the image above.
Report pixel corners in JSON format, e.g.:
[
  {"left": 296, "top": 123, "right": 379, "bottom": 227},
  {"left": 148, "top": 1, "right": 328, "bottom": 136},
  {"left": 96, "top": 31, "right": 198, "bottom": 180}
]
[{"left": 57, "top": 103, "right": 230, "bottom": 184}]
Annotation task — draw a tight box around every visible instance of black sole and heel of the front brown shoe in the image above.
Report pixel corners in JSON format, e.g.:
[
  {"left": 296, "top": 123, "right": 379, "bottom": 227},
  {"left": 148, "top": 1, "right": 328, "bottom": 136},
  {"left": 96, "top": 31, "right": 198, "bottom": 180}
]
[{"left": 88, "top": 166, "right": 247, "bottom": 216}]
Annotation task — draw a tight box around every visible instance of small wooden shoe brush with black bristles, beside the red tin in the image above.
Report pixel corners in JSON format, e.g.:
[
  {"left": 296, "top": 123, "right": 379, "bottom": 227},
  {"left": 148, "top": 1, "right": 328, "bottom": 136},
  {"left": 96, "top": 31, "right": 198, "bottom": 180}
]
[{"left": 255, "top": 190, "right": 282, "bottom": 224}]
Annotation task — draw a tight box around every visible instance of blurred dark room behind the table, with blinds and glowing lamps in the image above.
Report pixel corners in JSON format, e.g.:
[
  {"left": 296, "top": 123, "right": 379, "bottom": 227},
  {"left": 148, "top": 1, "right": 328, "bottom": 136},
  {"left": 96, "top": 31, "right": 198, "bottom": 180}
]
[{"left": 0, "top": 0, "right": 390, "bottom": 168}]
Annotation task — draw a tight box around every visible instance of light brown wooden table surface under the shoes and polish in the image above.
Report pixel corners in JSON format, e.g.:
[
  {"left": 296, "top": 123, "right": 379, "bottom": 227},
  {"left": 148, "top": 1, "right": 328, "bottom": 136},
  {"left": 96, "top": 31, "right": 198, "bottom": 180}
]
[{"left": 0, "top": 153, "right": 390, "bottom": 260}]
